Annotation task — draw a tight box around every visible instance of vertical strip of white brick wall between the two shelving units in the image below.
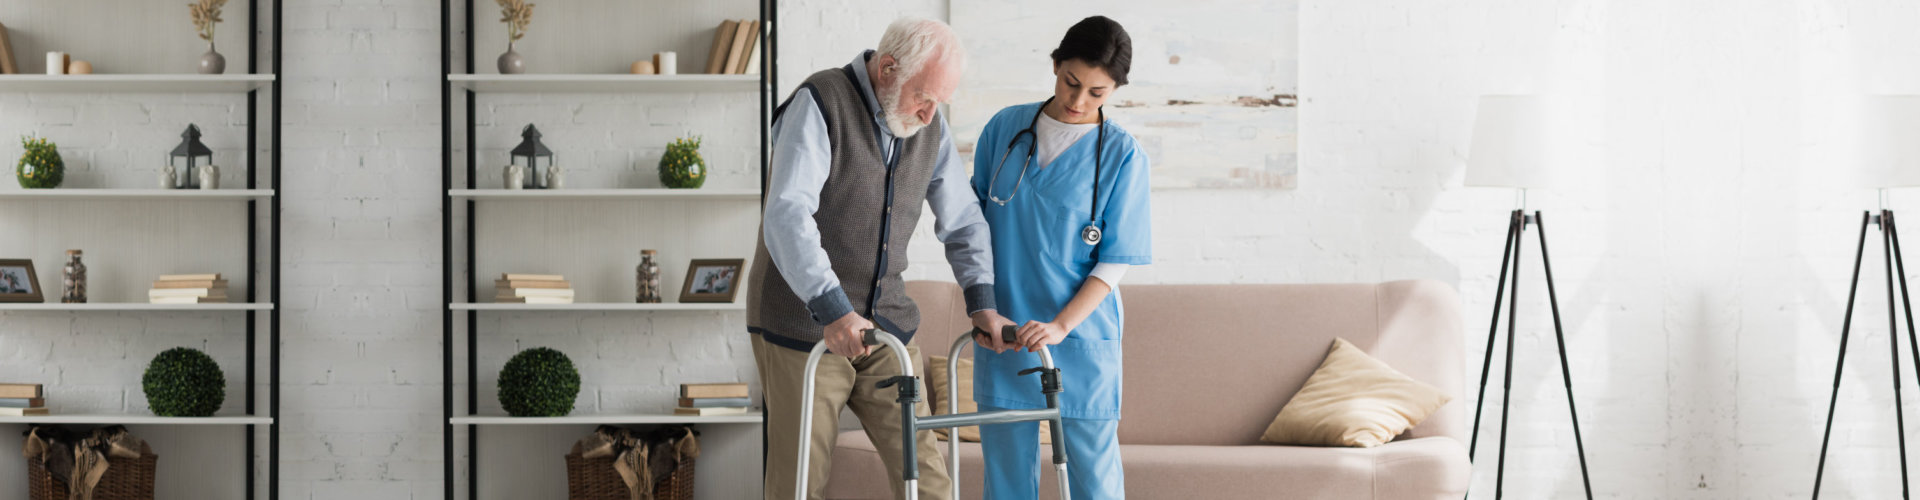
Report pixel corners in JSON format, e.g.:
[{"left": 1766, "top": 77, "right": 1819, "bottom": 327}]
[{"left": 280, "top": 0, "right": 442, "bottom": 500}]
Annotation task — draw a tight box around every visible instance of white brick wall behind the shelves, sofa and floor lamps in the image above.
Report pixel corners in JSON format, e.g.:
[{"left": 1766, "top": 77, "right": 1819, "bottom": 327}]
[{"left": 0, "top": 0, "right": 1920, "bottom": 498}]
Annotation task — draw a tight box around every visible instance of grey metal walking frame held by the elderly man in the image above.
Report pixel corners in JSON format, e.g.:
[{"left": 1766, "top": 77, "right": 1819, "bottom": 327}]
[{"left": 793, "top": 327, "right": 1071, "bottom": 500}]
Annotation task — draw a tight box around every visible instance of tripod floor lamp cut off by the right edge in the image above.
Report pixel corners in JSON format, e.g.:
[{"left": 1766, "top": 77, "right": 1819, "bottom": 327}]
[{"left": 1812, "top": 96, "right": 1920, "bottom": 498}]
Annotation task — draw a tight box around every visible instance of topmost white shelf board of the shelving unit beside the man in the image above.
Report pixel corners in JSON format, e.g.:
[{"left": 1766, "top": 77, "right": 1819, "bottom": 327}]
[{"left": 447, "top": 75, "right": 760, "bottom": 92}]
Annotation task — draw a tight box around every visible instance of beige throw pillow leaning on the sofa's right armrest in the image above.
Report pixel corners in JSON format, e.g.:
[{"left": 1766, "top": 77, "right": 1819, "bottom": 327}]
[{"left": 1260, "top": 338, "right": 1452, "bottom": 448}]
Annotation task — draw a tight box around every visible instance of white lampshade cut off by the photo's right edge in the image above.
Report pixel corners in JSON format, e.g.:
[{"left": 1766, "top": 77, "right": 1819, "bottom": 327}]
[{"left": 1855, "top": 96, "right": 1920, "bottom": 188}]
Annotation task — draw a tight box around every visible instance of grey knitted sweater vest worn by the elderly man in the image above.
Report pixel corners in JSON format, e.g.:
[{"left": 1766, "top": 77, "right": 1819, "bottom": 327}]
[{"left": 747, "top": 65, "right": 947, "bottom": 350}]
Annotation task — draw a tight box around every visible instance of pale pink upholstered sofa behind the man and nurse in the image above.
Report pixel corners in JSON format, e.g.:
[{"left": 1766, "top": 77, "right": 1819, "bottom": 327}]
[{"left": 826, "top": 281, "right": 1471, "bottom": 500}]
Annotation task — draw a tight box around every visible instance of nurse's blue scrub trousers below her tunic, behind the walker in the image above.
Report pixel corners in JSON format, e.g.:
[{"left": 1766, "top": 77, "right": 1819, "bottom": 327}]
[{"left": 979, "top": 404, "right": 1127, "bottom": 500}]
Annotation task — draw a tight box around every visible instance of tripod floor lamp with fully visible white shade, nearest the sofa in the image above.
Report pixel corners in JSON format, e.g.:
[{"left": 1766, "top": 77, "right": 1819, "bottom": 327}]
[{"left": 1467, "top": 96, "right": 1594, "bottom": 500}]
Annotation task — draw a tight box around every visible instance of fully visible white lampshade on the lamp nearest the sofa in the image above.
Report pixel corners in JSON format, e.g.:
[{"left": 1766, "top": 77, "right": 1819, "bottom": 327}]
[{"left": 1467, "top": 96, "right": 1561, "bottom": 188}]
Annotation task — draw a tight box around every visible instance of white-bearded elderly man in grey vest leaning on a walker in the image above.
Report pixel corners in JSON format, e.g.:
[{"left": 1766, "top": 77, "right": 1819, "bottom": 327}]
[{"left": 747, "top": 19, "right": 1012, "bottom": 500}]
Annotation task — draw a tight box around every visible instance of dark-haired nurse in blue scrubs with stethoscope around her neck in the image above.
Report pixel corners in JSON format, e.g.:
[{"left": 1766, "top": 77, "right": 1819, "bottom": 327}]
[{"left": 973, "top": 15, "right": 1152, "bottom": 500}]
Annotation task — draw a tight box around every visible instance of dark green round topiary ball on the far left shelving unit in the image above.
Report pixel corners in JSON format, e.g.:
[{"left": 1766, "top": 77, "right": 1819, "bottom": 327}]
[{"left": 140, "top": 348, "right": 227, "bottom": 417}]
